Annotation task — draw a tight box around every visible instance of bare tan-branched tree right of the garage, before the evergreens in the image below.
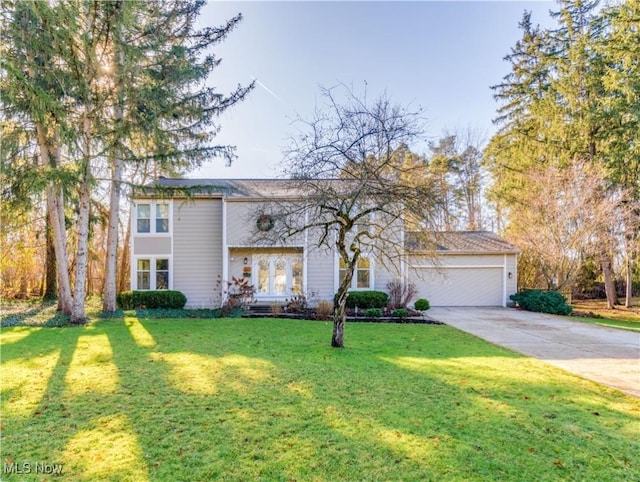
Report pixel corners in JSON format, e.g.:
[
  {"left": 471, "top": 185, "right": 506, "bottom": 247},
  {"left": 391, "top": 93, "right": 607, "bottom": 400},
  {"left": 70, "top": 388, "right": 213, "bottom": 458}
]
[{"left": 509, "top": 161, "right": 620, "bottom": 290}]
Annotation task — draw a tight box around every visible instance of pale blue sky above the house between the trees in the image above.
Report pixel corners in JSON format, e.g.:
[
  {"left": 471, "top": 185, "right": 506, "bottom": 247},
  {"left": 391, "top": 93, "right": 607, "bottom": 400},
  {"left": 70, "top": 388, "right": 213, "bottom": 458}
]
[{"left": 195, "top": 1, "right": 556, "bottom": 178}]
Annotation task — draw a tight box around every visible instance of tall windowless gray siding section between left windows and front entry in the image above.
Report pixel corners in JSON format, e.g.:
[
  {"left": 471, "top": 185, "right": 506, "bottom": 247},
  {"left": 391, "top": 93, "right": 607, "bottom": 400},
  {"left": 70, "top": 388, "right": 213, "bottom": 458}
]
[{"left": 173, "top": 199, "right": 222, "bottom": 308}]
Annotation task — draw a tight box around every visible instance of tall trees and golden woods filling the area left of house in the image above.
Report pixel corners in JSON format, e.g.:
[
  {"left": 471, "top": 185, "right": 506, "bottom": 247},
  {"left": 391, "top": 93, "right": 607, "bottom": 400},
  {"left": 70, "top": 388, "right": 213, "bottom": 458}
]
[{"left": 0, "top": 0, "right": 252, "bottom": 323}]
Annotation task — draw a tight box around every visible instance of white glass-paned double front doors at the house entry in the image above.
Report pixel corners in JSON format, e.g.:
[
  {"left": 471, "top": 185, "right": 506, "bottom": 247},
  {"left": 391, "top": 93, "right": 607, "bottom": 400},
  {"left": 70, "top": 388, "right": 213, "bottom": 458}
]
[{"left": 253, "top": 253, "right": 302, "bottom": 299}]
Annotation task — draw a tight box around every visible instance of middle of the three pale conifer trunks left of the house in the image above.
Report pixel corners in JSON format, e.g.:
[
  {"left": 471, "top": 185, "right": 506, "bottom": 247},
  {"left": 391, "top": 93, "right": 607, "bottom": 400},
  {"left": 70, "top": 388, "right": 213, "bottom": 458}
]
[{"left": 70, "top": 165, "right": 91, "bottom": 325}]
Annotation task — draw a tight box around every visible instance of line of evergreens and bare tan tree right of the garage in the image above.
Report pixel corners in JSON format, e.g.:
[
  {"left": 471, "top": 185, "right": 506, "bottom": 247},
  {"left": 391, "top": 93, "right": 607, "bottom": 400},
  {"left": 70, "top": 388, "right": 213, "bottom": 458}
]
[{"left": 484, "top": 0, "right": 640, "bottom": 308}]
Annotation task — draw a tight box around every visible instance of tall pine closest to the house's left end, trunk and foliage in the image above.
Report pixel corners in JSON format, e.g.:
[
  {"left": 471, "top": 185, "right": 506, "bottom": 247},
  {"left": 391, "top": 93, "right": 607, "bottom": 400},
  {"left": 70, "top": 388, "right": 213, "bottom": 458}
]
[{"left": 103, "top": 1, "right": 253, "bottom": 311}]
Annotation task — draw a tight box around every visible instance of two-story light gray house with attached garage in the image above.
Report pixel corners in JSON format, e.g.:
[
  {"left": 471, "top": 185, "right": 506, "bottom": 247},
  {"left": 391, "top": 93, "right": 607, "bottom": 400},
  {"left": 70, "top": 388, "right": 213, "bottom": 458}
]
[{"left": 131, "top": 178, "right": 519, "bottom": 308}]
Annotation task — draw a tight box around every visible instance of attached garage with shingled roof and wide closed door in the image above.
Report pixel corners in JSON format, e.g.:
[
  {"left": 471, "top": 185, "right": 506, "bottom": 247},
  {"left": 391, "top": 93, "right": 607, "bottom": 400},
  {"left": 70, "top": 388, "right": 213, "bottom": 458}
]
[{"left": 410, "top": 231, "right": 519, "bottom": 306}]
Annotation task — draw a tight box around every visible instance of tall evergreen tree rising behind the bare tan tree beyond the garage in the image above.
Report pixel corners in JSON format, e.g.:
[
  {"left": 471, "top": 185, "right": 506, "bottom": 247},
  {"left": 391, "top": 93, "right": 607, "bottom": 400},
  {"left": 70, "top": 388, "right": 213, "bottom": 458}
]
[{"left": 485, "top": 0, "right": 638, "bottom": 307}]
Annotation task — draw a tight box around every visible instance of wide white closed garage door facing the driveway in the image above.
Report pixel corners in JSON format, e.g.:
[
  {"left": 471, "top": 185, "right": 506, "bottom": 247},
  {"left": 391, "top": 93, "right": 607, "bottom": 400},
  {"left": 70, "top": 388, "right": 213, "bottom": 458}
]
[{"left": 415, "top": 267, "right": 504, "bottom": 306}]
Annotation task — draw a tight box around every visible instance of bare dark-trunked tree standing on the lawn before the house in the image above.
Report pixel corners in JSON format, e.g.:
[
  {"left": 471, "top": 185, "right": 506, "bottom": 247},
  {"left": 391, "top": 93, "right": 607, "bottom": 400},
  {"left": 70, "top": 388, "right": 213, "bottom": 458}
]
[{"left": 272, "top": 85, "right": 434, "bottom": 347}]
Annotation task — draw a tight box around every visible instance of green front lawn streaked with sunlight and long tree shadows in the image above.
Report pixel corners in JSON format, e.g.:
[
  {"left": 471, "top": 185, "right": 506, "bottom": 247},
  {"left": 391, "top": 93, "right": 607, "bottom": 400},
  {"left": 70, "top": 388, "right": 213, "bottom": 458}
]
[{"left": 0, "top": 318, "right": 640, "bottom": 482}]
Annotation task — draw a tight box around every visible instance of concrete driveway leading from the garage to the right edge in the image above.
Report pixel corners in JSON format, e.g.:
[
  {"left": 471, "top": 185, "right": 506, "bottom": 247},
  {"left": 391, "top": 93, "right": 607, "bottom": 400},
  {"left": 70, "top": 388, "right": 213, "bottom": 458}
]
[{"left": 428, "top": 307, "right": 640, "bottom": 398}]
